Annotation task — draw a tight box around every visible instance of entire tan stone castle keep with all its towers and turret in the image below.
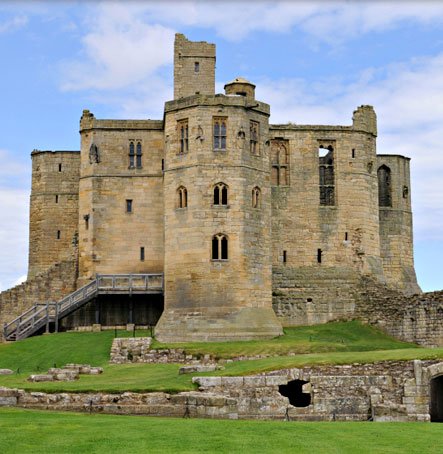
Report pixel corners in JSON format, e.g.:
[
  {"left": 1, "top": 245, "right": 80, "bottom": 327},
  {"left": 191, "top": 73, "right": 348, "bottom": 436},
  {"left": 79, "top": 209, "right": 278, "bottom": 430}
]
[{"left": 0, "top": 34, "right": 443, "bottom": 345}]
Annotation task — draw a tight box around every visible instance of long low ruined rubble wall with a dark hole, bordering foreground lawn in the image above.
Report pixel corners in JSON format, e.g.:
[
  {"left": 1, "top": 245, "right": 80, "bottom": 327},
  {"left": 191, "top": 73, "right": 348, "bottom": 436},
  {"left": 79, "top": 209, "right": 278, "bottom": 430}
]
[{"left": 0, "top": 360, "right": 443, "bottom": 422}]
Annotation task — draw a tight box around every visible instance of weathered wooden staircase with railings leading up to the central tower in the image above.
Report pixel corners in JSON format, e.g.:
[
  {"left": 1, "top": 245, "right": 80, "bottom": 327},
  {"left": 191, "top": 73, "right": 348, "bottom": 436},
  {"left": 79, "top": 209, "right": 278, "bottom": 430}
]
[{"left": 3, "top": 274, "right": 164, "bottom": 341}]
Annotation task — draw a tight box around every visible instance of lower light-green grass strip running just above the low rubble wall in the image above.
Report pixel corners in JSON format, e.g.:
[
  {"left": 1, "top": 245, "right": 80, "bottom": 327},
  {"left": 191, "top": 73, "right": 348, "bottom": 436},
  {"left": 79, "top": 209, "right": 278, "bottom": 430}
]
[{"left": 0, "top": 348, "right": 443, "bottom": 393}]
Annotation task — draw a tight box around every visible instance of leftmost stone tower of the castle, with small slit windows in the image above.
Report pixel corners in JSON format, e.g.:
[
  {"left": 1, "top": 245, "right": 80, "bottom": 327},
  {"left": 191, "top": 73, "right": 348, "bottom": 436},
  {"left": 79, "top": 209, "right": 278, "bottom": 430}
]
[{"left": 28, "top": 150, "right": 80, "bottom": 279}]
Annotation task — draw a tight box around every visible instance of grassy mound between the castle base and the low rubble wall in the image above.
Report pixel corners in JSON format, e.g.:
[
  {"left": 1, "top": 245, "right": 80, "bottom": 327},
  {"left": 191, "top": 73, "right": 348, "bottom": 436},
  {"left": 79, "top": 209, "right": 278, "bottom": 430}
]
[{"left": 0, "top": 321, "right": 443, "bottom": 392}]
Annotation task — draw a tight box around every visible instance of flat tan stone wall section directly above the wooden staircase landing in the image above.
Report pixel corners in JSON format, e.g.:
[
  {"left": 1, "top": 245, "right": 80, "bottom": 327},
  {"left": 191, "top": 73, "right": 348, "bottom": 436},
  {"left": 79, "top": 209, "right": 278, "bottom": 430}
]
[{"left": 79, "top": 111, "right": 164, "bottom": 283}]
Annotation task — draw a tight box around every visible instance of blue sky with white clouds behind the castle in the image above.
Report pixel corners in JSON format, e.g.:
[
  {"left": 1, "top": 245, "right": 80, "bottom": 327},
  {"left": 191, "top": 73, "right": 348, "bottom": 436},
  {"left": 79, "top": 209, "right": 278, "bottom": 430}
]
[{"left": 0, "top": 0, "right": 443, "bottom": 291}]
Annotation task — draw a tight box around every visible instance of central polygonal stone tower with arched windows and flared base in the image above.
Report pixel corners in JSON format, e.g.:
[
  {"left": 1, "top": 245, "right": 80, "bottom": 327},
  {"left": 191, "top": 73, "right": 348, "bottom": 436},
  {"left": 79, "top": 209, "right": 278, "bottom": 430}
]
[{"left": 156, "top": 35, "right": 282, "bottom": 342}]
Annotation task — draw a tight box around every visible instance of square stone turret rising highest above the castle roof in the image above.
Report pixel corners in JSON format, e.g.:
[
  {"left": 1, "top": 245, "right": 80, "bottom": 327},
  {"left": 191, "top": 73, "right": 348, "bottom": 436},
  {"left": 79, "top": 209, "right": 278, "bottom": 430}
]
[{"left": 174, "top": 33, "right": 215, "bottom": 99}]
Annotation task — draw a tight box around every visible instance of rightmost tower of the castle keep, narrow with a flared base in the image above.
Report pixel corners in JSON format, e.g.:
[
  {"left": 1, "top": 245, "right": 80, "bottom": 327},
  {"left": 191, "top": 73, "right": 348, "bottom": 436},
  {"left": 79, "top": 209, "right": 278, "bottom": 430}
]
[{"left": 377, "top": 155, "right": 420, "bottom": 294}]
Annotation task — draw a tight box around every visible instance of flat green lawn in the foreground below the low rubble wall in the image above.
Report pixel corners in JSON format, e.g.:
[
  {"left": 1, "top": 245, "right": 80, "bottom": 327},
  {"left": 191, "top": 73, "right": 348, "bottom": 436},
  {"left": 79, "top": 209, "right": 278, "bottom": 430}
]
[{"left": 0, "top": 408, "right": 443, "bottom": 454}]
